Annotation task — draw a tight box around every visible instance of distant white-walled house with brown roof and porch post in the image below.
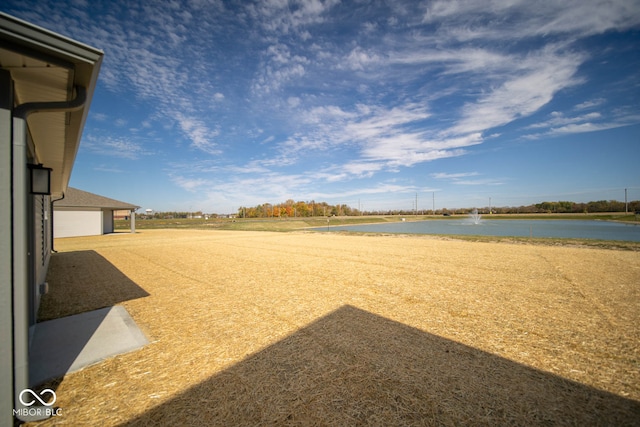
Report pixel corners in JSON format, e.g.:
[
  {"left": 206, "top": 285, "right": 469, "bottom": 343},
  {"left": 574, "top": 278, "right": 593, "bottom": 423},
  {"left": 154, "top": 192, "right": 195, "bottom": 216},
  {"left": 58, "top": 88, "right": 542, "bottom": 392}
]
[{"left": 53, "top": 187, "right": 140, "bottom": 238}]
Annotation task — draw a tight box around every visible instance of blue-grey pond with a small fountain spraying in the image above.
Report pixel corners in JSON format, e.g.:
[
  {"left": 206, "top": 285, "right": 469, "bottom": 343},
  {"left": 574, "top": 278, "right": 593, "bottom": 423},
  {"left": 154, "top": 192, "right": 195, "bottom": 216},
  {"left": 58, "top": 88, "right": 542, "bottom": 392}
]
[{"left": 315, "top": 219, "right": 640, "bottom": 242}]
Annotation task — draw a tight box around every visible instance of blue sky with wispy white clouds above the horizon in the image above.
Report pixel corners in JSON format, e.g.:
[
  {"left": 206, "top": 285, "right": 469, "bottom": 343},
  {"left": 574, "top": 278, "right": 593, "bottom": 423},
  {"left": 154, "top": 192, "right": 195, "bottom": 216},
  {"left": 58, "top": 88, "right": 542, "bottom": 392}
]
[{"left": 2, "top": 0, "right": 640, "bottom": 213}]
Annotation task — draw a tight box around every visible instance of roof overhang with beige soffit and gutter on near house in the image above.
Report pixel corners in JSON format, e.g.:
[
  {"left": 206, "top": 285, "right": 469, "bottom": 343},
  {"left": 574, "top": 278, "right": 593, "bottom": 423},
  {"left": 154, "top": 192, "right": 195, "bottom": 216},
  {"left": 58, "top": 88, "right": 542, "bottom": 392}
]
[{"left": 0, "top": 12, "right": 104, "bottom": 195}]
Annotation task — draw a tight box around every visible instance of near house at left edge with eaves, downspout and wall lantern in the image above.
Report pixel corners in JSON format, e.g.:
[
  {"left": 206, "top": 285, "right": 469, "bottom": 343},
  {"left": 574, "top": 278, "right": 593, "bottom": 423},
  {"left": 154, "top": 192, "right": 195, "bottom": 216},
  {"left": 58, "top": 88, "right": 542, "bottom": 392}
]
[{"left": 0, "top": 12, "right": 104, "bottom": 426}]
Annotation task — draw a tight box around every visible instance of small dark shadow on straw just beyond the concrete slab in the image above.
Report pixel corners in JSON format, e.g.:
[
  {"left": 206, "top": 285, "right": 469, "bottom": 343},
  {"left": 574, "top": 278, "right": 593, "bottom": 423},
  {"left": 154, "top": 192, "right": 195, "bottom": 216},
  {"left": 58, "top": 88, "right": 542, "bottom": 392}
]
[{"left": 38, "top": 251, "right": 149, "bottom": 322}]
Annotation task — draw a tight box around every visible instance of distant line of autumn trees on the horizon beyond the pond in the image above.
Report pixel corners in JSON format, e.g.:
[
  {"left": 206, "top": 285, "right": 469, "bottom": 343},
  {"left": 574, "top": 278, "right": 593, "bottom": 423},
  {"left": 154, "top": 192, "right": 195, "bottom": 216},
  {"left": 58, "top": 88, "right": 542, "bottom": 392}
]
[{"left": 237, "top": 199, "right": 640, "bottom": 218}]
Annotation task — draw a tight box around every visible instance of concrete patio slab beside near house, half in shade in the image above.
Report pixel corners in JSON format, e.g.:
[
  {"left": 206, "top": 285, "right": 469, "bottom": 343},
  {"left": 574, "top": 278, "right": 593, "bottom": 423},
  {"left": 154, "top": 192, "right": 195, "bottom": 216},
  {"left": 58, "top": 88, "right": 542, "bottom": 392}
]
[{"left": 29, "top": 306, "right": 149, "bottom": 386}]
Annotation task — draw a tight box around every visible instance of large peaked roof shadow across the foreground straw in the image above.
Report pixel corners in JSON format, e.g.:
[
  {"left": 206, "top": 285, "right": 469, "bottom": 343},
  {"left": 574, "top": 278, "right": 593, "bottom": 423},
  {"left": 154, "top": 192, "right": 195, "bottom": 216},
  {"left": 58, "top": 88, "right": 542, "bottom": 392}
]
[{"left": 123, "top": 306, "right": 640, "bottom": 426}]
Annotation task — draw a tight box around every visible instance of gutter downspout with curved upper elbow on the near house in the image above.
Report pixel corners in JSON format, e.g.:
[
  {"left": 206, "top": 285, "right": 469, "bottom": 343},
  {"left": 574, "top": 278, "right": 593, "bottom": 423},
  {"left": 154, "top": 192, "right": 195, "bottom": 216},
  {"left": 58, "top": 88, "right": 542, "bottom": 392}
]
[{"left": 11, "top": 86, "right": 87, "bottom": 421}]
